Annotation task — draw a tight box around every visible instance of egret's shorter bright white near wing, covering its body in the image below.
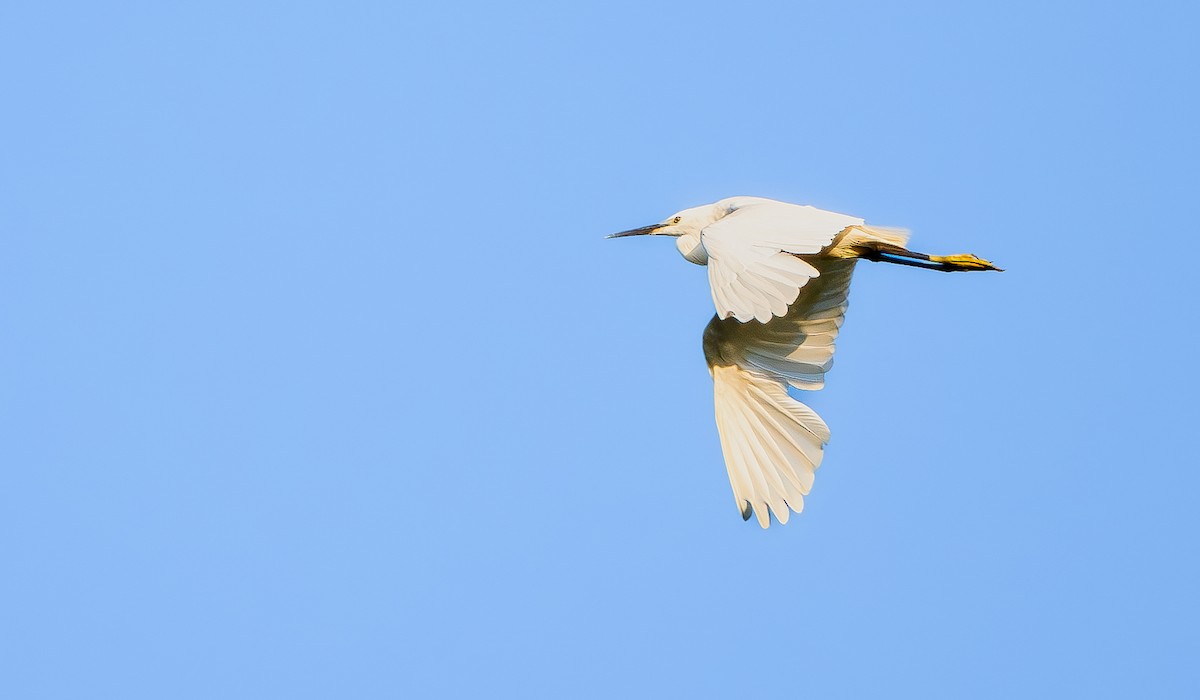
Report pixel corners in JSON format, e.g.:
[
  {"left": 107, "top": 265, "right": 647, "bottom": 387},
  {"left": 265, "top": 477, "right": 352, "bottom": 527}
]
[{"left": 701, "top": 199, "right": 863, "bottom": 323}]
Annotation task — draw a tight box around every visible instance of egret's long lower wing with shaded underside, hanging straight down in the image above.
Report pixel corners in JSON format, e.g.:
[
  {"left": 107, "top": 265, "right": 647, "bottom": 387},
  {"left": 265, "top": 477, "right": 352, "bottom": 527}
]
[{"left": 704, "top": 259, "right": 854, "bottom": 527}]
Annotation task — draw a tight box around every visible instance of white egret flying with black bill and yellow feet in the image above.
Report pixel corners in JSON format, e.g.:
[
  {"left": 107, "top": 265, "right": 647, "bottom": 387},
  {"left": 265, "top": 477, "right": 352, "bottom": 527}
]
[{"left": 608, "top": 197, "right": 1000, "bottom": 528}]
